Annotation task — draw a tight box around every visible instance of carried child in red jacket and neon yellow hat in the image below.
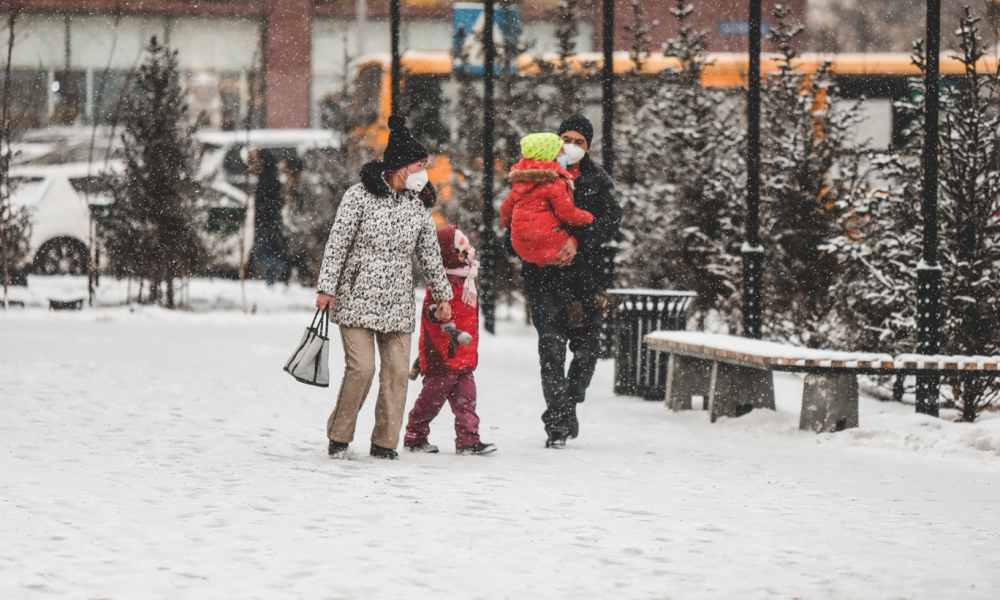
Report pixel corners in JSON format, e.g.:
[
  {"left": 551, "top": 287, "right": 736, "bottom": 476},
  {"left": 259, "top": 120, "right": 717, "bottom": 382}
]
[{"left": 500, "top": 133, "right": 594, "bottom": 267}]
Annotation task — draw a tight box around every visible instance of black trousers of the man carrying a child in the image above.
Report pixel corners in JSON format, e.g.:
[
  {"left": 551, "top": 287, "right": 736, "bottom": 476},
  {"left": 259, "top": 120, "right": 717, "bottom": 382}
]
[{"left": 527, "top": 285, "right": 601, "bottom": 435}]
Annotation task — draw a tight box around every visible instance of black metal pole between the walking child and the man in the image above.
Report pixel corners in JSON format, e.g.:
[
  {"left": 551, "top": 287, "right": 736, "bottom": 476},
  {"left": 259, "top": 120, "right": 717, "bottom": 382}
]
[{"left": 480, "top": 0, "right": 496, "bottom": 333}]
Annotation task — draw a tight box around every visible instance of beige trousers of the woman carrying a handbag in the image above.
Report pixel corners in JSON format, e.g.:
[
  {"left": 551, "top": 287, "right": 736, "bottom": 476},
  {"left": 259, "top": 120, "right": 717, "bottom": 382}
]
[{"left": 326, "top": 327, "right": 412, "bottom": 449}]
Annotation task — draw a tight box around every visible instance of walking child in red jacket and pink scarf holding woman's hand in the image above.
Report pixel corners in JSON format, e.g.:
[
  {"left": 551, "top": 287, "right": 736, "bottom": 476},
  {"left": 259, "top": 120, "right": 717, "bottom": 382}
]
[{"left": 403, "top": 225, "right": 497, "bottom": 454}]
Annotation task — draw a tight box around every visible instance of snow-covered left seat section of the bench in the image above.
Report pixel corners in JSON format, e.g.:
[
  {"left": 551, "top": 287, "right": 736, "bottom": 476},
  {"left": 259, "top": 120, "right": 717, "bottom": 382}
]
[{"left": 646, "top": 331, "right": 896, "bottom": 369}]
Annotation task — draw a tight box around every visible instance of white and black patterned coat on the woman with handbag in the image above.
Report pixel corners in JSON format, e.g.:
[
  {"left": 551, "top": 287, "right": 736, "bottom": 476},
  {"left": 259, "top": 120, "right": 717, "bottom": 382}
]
[{"left": 316, "top": 165, "right": 452, "bottom": 333}]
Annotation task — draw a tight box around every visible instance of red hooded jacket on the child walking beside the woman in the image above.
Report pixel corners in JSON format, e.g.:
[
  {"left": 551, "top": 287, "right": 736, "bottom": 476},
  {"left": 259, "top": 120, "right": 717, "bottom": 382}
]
[{"left": 420, "top": 225, "right": 479, "bottom": 374}]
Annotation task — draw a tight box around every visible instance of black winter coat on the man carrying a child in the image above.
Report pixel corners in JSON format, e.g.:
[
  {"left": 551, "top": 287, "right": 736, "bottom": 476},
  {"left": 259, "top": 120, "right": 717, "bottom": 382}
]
[{"left": 521, "top": 154, "right": 622, "bottom": 305}]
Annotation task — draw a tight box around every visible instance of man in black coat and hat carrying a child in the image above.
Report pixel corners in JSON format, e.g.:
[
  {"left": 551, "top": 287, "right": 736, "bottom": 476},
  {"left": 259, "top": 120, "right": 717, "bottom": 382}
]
[{"left": 521, "top": 115, "right": 622, "bottom": 448}]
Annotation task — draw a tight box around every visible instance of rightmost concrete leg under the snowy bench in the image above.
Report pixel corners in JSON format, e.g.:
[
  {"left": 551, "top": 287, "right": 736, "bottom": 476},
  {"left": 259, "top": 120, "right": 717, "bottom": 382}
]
[{"left": 799, "top": 373, "right": 858, "bottom": 433}]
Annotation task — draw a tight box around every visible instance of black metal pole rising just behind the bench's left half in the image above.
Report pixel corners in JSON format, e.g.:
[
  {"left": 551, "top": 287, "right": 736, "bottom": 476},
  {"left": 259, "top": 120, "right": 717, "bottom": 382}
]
[{"left": 742, "top": 0, "right": 764, "bottom": 340}]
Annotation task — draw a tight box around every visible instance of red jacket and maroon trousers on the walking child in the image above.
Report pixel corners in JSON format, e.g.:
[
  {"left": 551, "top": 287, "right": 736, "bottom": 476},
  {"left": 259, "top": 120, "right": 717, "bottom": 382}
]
[{"left": 403, "top": 225, "right": 479, "bottom": 450}]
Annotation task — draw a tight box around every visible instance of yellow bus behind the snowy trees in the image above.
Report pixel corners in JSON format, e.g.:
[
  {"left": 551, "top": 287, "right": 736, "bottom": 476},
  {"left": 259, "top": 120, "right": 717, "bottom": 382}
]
[{"left": 350, "top": 51, "right": 997, "bottom": 200}]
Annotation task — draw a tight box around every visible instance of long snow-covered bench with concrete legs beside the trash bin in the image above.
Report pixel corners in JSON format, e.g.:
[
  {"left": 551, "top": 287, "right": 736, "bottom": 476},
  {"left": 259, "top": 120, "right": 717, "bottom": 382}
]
[{"left": 645, "top": 331, "right": 1000, "bottom": 431}]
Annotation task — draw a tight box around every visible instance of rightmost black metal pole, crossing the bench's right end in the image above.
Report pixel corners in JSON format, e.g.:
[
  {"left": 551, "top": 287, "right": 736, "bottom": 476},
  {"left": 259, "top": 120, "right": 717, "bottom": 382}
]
[{"left": 917, "top": 0, "right": 941, "bottom": 416}]
